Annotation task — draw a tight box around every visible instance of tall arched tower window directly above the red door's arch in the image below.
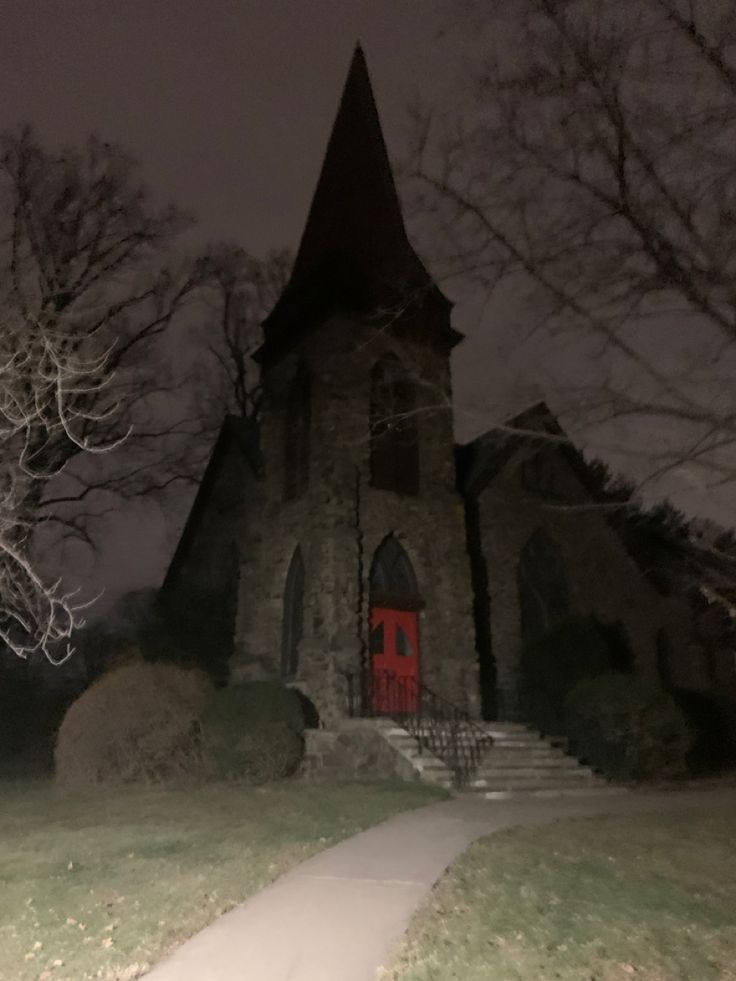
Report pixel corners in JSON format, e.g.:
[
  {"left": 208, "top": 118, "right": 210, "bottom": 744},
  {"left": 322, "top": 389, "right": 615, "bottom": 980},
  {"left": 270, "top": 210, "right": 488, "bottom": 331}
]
[{"left": 370, "top": 355, "right": 419, "bottom": 494}]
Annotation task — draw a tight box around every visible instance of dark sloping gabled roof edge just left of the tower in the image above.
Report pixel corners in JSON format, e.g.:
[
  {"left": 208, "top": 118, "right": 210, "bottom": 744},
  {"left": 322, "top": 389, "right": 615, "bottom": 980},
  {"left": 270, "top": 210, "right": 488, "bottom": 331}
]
[{"left": 161, "top": 416, "right": 262, "bottom": 592}]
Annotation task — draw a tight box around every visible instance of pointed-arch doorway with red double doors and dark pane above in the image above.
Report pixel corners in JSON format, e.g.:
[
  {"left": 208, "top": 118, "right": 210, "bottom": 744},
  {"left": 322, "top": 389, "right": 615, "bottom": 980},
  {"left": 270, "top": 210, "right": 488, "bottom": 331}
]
[{"left": 370, "top": 535, "right": 422, "bottom": 715}]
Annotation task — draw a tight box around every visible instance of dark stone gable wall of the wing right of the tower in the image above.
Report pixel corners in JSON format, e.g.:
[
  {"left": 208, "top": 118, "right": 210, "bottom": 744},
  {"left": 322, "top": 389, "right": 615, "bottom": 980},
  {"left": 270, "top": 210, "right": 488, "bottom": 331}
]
[{"left": 478, "top": 451, "right": 706, "bottom": 718}]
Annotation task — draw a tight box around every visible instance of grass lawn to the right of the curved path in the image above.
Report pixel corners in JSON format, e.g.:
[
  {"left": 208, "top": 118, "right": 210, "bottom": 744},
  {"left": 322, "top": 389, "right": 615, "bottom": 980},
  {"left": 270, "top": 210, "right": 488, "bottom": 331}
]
[{"left": 384, "top": 810, "right": 736, "bottom": 981}]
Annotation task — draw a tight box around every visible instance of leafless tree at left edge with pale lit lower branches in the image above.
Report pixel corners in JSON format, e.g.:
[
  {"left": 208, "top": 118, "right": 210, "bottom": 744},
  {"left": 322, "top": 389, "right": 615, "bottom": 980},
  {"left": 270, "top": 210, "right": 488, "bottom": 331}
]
[{"left": 0, "top": 129, "right": 206, "bottom": 657}]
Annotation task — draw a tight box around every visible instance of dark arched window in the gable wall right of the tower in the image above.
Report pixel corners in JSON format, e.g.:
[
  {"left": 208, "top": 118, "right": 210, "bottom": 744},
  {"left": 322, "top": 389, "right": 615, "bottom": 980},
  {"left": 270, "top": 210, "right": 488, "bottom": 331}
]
[{"left": 517, "top": 529, "right": 570, "bottom": 643}]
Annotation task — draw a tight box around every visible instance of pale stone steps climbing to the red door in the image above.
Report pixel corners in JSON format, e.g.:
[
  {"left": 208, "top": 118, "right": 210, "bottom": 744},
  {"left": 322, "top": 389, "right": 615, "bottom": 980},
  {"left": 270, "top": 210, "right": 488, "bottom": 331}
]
[{"left": 376, "top": 719, "right": 622, "bottom": 800}]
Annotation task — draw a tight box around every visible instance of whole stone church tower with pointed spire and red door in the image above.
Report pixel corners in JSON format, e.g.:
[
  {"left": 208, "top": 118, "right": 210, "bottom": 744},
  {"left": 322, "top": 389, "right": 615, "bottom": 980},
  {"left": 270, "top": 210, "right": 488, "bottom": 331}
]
[{"left": 233, "top": 47, "right": 478, "bottom": 722}]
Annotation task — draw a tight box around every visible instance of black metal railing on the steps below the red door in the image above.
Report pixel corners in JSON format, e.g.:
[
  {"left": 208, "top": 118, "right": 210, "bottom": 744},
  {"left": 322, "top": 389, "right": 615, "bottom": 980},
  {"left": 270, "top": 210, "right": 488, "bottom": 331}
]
[{"left": 348, "top": 671, "right": 493, "bottom": 787}]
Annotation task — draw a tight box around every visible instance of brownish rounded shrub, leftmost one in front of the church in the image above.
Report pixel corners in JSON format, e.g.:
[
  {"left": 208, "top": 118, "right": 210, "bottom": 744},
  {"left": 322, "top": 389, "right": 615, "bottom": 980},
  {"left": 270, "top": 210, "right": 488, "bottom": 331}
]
[{"left": 54, "top": 661, "right": 212, "bottom": 787}]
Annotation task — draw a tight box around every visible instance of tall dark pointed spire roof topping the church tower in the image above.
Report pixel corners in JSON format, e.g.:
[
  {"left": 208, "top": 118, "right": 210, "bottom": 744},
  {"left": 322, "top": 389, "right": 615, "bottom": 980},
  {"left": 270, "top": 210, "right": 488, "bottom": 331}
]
[{"left": 258, "top": 44, "right": 459, "bottom": 361}]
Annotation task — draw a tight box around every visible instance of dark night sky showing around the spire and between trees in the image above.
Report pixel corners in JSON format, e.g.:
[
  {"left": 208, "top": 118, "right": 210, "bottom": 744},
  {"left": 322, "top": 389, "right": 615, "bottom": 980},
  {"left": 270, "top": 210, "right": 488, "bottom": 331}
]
[{"left": 0, "top": 0, "right": 733, "bottom": 612}]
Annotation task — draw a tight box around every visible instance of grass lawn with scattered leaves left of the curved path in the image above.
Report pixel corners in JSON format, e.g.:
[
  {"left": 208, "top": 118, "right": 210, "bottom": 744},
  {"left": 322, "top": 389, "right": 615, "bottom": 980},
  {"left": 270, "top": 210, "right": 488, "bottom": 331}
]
[{"left": 0, "top": 783, "right": 438, "bottom": 981}]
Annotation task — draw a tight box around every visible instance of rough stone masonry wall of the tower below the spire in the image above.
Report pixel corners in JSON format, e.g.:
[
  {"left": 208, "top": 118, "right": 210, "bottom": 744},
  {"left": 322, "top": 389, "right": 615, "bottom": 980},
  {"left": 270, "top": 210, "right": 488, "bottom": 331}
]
[{"left": 233, "top": 317, "right": 478, "bottom": 724}]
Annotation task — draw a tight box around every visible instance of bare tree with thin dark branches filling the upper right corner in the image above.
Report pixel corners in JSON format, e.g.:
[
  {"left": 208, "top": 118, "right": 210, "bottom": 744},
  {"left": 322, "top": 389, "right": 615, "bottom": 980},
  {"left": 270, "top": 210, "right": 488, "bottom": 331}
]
[{"left": 411, "top": 0, "right": 736, "bottom": 498}]
